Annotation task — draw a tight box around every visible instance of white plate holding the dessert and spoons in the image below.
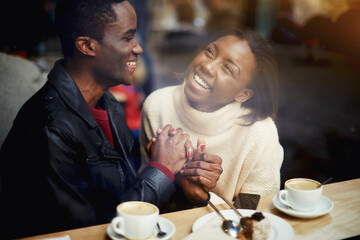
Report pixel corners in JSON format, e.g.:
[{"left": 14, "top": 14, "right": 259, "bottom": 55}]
[{"left": 192, "top": 209, "right": 294, "bottom": 240}]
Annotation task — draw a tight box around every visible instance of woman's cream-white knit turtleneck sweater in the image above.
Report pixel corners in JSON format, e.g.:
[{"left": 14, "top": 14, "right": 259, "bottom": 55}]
[{"left": 140, "top": 84, "right": 283, "bottom": 202}]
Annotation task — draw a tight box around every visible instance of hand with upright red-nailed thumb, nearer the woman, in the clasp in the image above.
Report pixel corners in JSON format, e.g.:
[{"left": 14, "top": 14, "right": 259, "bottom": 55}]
[{"left": 180, "top": 139, "right": 223, "bottom": 192}]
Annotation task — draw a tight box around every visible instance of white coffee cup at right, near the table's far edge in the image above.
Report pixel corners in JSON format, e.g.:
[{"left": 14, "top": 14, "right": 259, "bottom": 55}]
[{"left": 278, "top": 178, "right": 323, "bottom": 212}]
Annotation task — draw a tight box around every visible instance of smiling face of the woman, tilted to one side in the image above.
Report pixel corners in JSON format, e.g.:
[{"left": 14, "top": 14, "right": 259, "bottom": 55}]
[{"left": 184, "top": 35, "right": 256, "bottom": 112}]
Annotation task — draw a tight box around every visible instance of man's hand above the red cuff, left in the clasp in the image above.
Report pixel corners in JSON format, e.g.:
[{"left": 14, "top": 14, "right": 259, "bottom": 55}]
[{"left": 147, "top": 125, "right": 192, "bottom": 175}]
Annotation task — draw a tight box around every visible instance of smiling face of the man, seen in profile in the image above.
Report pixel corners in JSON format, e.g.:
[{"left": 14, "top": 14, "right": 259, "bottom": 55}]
[{"left": 94, "top": 1, "right": 143, "bottom": 87}]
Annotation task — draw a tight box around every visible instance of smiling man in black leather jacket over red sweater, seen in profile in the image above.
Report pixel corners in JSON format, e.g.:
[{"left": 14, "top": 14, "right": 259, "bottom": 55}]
[{"left": 0, "top": 0, "right": 197, "bottom": 239}]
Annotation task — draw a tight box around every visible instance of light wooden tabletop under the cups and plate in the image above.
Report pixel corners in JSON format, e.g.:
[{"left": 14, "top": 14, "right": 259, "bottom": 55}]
[{"left": 19, "top": 178, "right": 360, "bottom": 240}]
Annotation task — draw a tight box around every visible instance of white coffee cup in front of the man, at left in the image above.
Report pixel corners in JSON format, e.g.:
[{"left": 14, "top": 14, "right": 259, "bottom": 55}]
[{"left": 111, "top": 201, "right": 159, "bottom": 239}]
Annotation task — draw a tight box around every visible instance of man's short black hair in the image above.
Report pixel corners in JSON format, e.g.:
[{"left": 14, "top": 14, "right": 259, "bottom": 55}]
[{"left": 55, "top": 0, "right": 125, "bottom": 57}]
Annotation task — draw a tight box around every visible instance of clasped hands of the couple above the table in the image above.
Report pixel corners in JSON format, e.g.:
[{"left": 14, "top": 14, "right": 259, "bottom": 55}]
[{"left": 146, "top": 125, "right": 222, "bottom": 204}]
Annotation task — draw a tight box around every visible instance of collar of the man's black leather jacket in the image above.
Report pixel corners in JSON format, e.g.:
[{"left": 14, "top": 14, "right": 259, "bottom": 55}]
[{"left": 48, "top": 60, "right": 114, "bottom": 128}]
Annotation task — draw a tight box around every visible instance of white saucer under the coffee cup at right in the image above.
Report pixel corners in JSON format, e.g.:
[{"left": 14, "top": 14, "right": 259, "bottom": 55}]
[{"left": 273, "top": 195, "right": 334, "bottom": 218}]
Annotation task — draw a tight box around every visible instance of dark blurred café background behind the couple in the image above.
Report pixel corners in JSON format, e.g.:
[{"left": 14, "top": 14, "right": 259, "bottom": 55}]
[{"left": 0, "top": 0, "right": 360, "bottom": 186}]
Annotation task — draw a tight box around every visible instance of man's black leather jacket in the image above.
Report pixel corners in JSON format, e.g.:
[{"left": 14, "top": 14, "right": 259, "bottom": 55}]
[{"left": 0, "top": 61, "right": 175, "bottom": 236}]
